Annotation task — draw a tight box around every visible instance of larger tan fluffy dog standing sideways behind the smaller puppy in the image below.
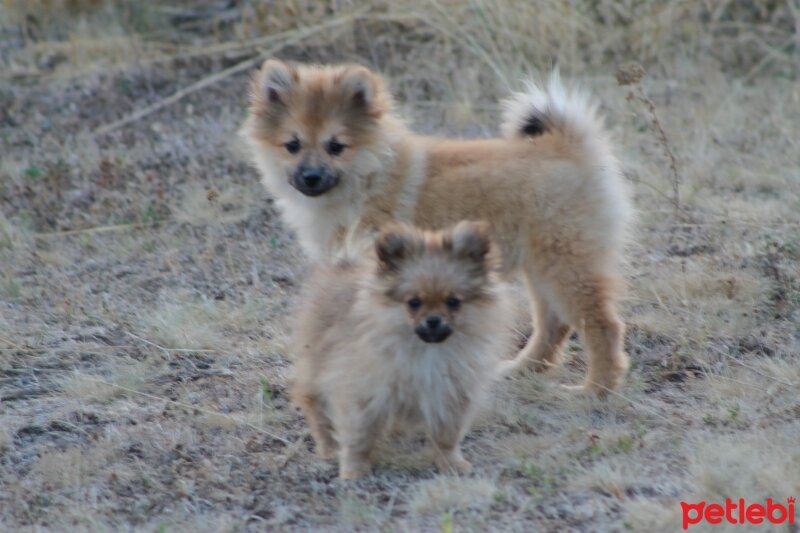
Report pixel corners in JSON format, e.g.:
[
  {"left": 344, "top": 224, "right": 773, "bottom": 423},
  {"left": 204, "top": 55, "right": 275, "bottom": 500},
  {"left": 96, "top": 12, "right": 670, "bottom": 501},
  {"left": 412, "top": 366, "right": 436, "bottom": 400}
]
[{"left": 244, "top": 60, "right": 630, "bottom": 391}]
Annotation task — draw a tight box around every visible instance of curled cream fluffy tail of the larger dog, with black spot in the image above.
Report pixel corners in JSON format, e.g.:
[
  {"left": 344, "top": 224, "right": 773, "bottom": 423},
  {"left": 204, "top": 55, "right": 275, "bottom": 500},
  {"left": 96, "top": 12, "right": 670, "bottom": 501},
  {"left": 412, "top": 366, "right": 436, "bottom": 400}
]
[{"left": 502, "top": 71, "right": 606, "bottom": 153}]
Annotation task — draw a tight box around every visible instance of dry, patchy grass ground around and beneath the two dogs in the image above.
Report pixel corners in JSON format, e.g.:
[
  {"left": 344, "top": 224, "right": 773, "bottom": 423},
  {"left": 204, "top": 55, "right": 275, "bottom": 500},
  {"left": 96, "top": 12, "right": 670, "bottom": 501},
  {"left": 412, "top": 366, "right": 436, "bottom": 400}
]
[{"left": 0, "top": 2, "right": 800, "bottom": 532}]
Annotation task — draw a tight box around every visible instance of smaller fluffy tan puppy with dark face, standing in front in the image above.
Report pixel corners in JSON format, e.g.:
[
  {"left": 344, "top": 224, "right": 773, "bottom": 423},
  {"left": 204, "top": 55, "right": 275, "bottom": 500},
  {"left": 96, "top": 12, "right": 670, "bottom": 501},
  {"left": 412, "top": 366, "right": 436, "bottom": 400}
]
[{"left": 291, "top": 222, "right": 511, "bottom": 479}]
